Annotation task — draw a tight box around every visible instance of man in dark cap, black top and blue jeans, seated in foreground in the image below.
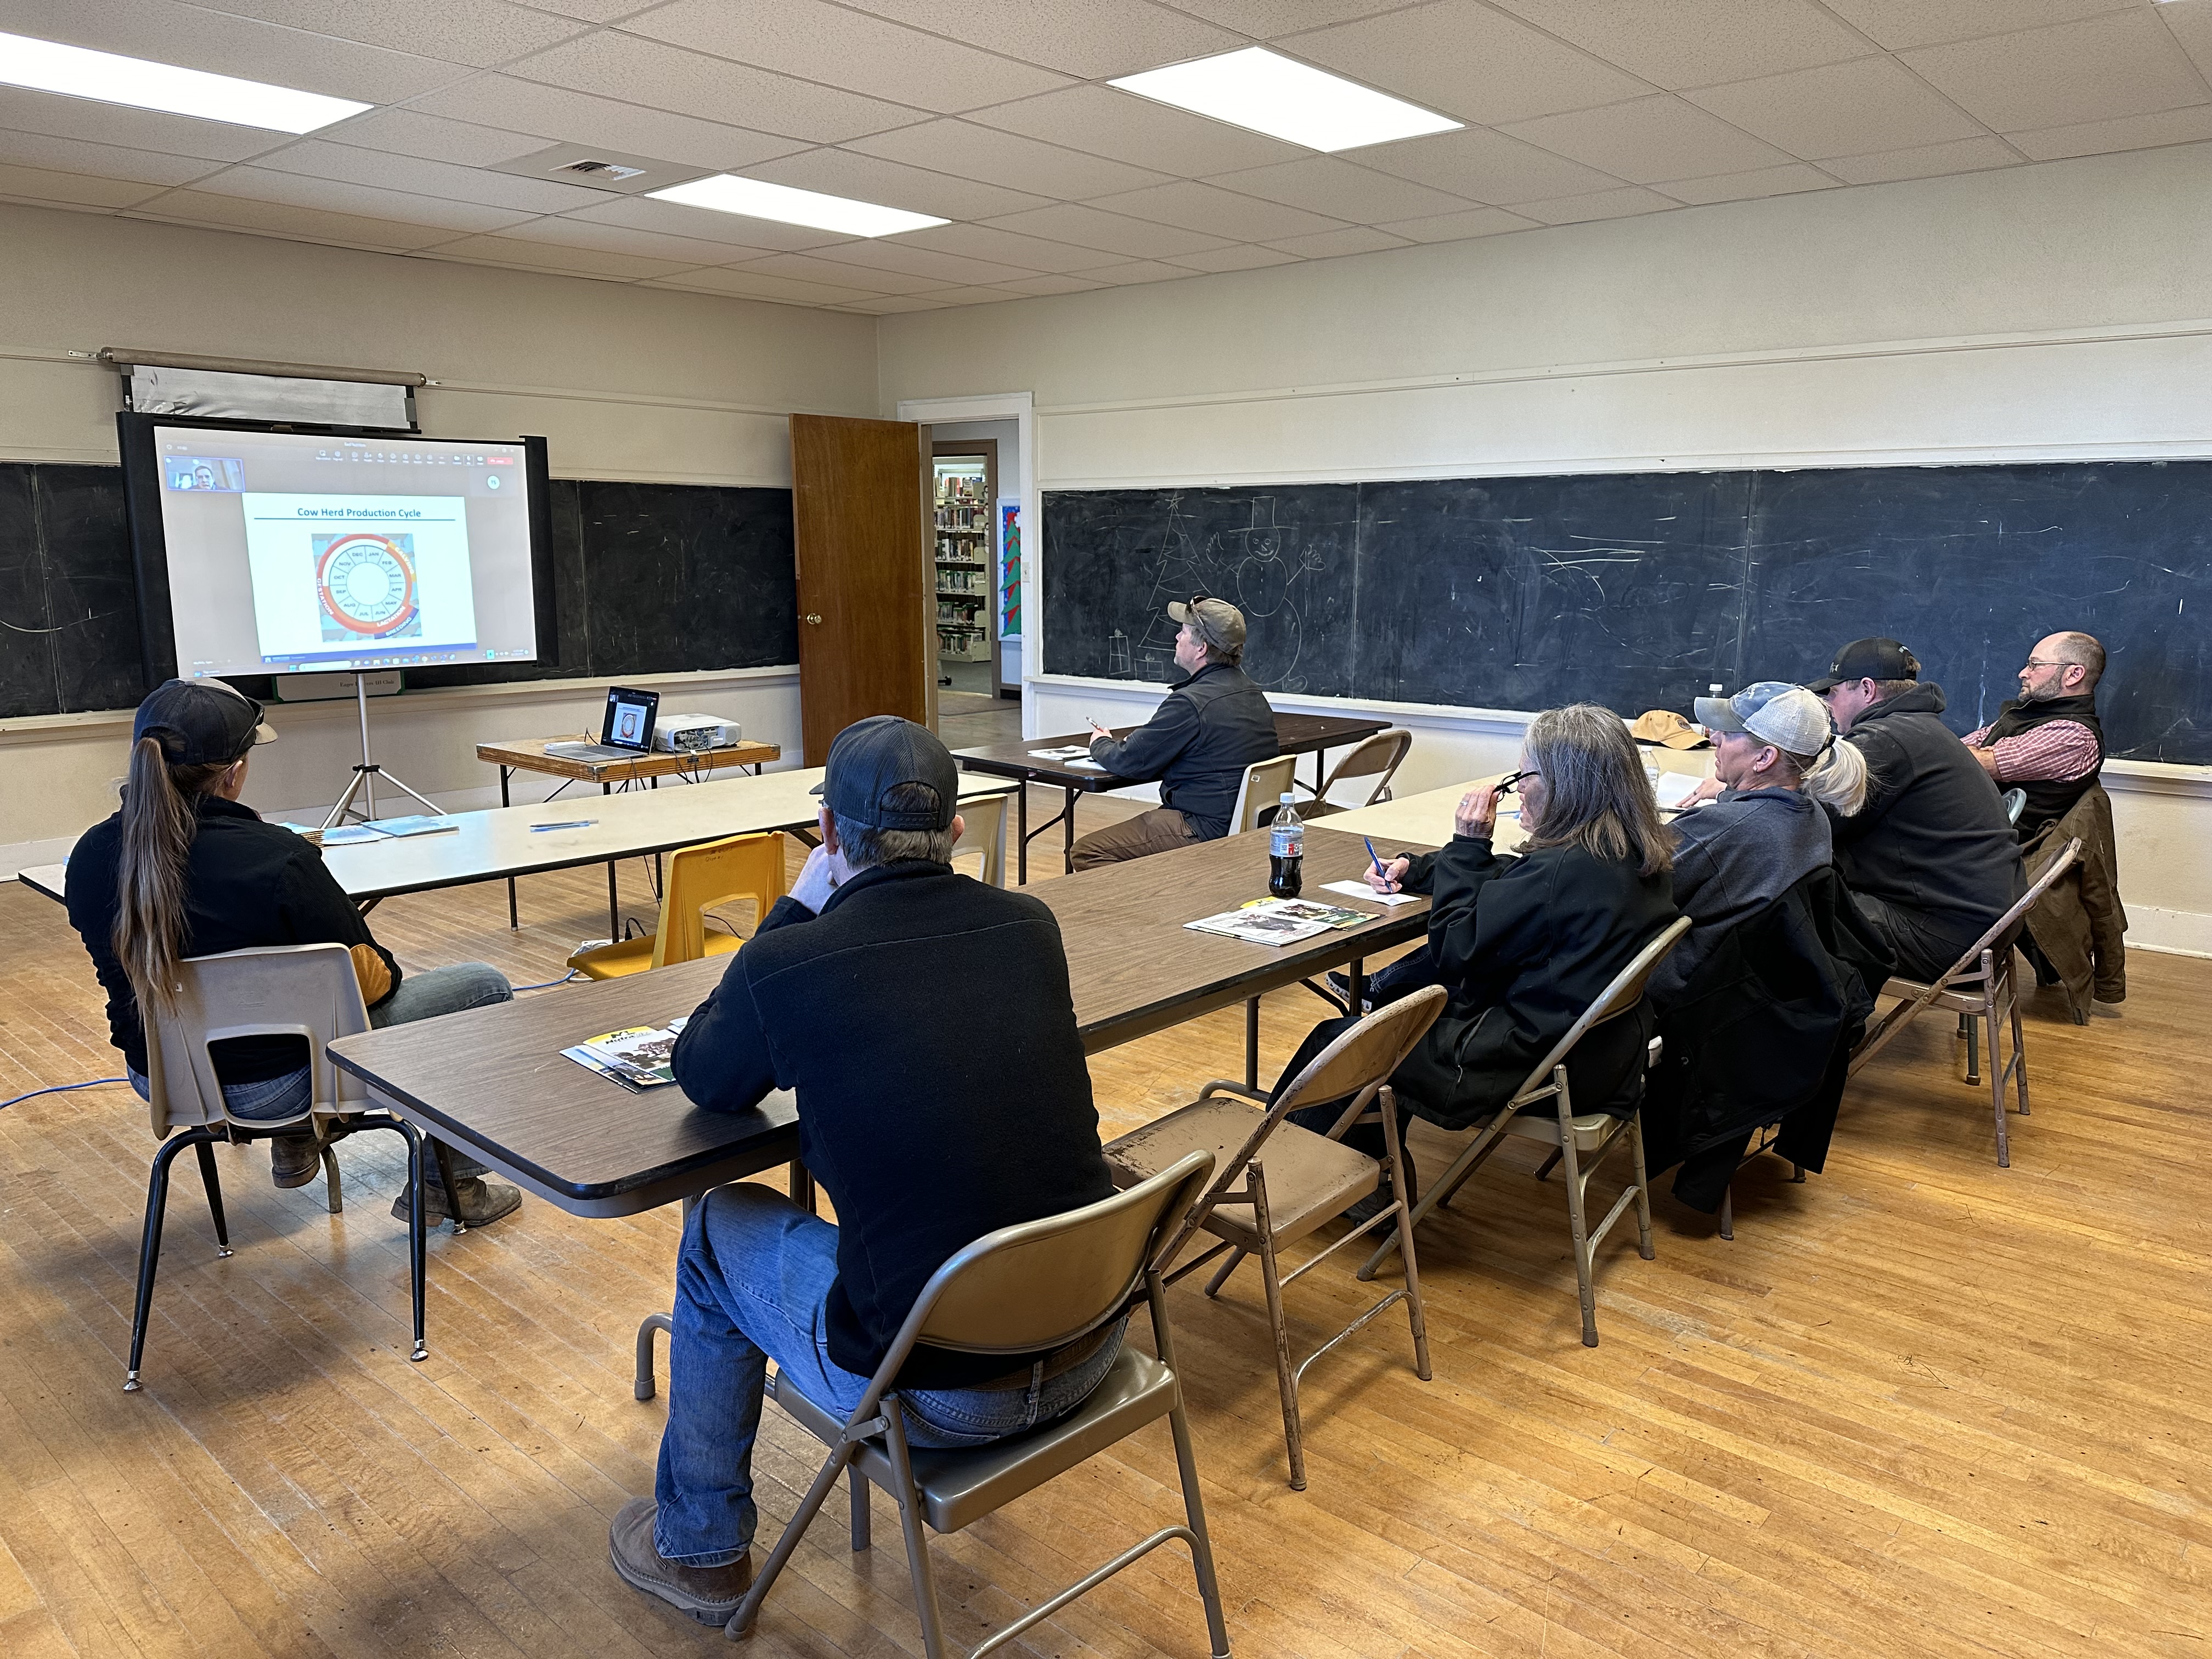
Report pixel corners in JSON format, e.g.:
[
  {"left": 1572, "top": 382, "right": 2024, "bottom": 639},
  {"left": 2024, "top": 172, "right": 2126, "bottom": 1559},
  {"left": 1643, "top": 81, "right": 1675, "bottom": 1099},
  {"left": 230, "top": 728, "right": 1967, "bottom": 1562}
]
[{"left": 608, "top": 714, "right": 1121, "bottom": 1623}]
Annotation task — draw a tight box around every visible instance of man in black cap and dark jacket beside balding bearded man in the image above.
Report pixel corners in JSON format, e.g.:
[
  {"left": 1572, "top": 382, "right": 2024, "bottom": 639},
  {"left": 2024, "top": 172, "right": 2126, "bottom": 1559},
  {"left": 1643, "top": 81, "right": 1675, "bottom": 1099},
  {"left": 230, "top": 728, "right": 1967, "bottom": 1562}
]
[{"left": 1807, "top": 639, "right": 2028, "bottom": 982}]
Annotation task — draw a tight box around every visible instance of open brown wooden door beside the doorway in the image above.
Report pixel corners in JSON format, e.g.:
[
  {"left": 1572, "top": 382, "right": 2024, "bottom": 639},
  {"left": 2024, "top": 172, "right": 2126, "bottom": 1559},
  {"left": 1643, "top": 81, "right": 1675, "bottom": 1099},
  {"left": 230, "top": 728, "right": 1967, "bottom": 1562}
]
[{"left": 792, "top": 416, "right": 938, "bottom": 765}]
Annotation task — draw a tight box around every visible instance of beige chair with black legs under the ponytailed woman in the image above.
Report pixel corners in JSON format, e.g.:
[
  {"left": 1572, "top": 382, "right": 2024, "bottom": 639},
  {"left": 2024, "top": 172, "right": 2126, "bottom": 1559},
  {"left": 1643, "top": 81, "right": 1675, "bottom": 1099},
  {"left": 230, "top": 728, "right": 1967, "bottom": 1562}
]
[{"left": 124, "top": 945, "right": 440, "bottom": 1393}]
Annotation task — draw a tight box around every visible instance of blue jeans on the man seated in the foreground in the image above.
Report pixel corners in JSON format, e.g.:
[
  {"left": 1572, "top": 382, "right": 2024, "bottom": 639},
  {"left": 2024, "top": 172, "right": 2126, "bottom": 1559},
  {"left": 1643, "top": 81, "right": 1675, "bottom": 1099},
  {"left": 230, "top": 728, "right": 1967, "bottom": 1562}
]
[{"left": 652, "top": 1183, "right": 1121, "bottom": 1566}]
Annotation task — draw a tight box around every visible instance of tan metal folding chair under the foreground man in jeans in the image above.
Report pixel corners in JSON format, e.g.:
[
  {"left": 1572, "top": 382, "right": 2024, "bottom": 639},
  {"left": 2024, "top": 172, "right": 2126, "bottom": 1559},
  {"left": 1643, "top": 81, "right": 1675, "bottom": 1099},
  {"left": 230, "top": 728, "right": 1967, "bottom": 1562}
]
[{"left": 725, "top": 1153, "right": 1230, "bottom": 1659}]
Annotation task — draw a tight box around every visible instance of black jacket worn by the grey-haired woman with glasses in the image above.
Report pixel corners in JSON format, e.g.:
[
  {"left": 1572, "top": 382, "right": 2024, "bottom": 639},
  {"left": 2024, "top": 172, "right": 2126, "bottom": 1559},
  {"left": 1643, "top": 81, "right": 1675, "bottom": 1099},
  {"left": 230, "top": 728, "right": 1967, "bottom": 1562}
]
[{"left": 1391, "top": 836, "right": 1677, "bottom": 1128}]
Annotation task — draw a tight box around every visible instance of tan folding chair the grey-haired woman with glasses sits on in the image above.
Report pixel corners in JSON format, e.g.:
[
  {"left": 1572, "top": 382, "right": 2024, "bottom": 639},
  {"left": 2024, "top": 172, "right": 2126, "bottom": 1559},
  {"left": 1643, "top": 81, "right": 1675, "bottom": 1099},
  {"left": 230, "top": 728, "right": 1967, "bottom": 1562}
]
[{"left": 1361, "top": 916, "right": 1690, "bottom": 1347}]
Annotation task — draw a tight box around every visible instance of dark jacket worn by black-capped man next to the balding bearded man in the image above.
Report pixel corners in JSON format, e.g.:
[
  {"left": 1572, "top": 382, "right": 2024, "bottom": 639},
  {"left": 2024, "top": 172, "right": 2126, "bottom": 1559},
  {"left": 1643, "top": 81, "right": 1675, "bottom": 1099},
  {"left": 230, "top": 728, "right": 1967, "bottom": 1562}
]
[{"left": 1829, "top": 686, "right": 2028, "bottom": 951}]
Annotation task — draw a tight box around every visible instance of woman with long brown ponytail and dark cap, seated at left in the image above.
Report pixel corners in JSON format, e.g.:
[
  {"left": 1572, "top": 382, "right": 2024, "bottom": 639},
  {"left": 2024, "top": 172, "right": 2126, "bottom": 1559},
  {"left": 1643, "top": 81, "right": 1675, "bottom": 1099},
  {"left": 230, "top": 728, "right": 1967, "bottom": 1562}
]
[{"left": 64, "top": 679, "right": 522, "bottom": 1226}]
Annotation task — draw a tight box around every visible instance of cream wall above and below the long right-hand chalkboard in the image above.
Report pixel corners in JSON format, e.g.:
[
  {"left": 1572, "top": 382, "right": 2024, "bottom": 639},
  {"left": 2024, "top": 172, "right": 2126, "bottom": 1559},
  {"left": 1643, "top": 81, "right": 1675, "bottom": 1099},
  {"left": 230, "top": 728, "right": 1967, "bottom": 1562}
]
[{"left": 878, "top": 144, "right": 2212, "bottom": 953}]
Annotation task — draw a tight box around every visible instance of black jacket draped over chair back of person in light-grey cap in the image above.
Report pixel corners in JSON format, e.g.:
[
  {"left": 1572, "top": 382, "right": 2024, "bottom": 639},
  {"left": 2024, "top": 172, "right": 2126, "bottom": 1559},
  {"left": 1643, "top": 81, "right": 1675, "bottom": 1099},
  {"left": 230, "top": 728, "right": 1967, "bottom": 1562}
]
[{"left": 1644, "top": 865, "right": 1895, "bottom": 1215}]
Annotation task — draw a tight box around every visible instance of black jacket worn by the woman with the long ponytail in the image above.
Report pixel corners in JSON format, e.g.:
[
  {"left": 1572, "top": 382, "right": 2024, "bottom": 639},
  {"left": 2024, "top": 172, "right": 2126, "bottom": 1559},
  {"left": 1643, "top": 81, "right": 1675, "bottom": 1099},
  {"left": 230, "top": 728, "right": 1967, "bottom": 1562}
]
[{"left": 62, "top": 794, "right": 400, "bottom": 1084}]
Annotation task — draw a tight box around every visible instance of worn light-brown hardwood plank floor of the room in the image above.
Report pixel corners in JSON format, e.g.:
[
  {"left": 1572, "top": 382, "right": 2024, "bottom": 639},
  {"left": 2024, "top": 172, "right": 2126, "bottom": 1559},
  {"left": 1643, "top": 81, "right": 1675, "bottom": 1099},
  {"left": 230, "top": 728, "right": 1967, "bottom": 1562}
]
[{"left": 0, "top": 787, "right": 2212, "bottom": 1659}]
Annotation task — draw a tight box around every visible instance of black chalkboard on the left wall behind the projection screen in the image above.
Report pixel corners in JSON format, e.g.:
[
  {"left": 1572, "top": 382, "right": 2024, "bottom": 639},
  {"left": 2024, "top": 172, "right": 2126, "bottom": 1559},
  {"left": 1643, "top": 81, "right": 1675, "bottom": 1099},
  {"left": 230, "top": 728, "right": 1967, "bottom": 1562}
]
[{"left": 0, "top": 462, "right": 799, "bottom": 719}]
